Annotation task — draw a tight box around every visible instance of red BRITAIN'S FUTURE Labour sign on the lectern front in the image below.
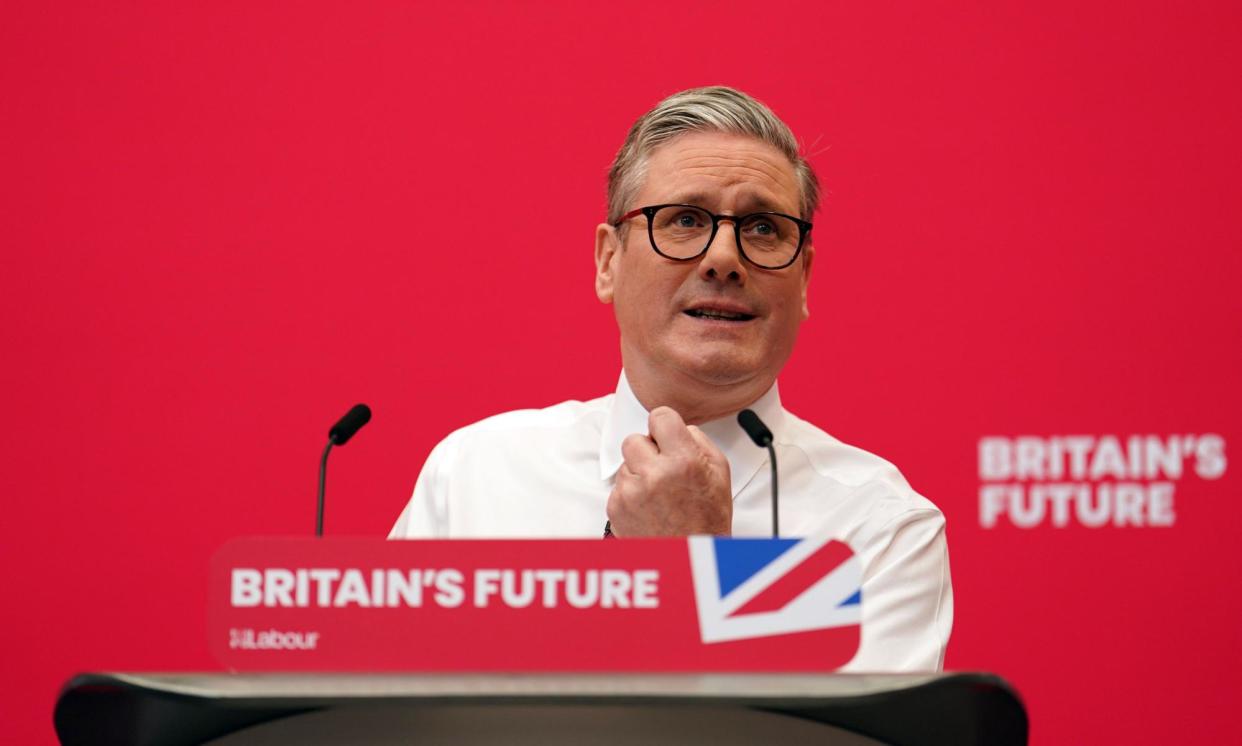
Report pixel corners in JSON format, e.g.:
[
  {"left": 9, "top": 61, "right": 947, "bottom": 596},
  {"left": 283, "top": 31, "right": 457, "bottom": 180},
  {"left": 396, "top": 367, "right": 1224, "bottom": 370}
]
[{"left": 207, "top": 536, "right": 862, "bottom": 672}]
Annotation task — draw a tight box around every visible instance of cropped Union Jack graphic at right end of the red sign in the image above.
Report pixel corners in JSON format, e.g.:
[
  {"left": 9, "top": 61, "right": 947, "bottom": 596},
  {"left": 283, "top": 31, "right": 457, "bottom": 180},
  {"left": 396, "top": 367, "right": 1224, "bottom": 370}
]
[{"left": 689, "top": 536, "right": 862, "bottom": 643}]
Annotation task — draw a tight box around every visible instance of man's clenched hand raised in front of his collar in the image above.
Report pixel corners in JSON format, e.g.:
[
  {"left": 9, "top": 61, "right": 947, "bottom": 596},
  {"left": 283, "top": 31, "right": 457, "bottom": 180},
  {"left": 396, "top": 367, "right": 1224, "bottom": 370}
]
[{"left": 607, "top": 407, "right": 733, "bottom": 536}]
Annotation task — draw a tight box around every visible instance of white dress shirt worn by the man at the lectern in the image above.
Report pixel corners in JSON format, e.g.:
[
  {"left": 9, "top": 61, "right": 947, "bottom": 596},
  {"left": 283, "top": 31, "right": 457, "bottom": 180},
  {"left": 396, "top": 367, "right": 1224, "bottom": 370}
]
[{"left": 389, "top": 374, "right": 953, "bottom": 672}]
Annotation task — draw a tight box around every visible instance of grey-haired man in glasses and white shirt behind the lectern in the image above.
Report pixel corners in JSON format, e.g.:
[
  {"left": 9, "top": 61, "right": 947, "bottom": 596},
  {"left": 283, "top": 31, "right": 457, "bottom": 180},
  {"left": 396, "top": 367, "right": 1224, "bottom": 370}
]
[{"left": 391, "top": 87, "right": 953, "bottom": 672}]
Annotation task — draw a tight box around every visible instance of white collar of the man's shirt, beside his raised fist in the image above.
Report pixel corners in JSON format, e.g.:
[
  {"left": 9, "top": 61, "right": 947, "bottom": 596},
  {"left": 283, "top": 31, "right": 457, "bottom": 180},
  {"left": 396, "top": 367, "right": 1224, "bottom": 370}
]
[{"left": 600, "top": 371, "right": 785, "bottom": 498}]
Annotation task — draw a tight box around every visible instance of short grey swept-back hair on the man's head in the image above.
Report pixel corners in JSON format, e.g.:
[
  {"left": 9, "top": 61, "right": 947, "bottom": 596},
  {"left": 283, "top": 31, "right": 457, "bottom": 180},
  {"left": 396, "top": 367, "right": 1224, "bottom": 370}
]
[{"left": 609, "top": 86, "right": 820, "bottom": 223}]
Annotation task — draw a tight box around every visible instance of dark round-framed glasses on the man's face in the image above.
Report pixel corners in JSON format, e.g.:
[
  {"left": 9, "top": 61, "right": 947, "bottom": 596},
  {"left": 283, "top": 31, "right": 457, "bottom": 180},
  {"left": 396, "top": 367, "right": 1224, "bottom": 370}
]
[{"left": 612, "top": 205, "right": 811, "bottom": 269}]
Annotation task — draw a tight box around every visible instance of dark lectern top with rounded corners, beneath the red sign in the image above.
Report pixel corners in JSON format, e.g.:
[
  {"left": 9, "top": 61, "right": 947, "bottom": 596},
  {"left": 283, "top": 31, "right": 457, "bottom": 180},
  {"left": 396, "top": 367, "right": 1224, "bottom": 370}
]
[{"left": 55, "top": 673, "right": 1028, "bottom": 746}]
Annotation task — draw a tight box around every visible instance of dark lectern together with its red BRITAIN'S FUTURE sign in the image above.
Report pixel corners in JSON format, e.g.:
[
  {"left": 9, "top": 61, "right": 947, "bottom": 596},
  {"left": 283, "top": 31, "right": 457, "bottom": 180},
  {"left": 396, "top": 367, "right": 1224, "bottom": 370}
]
[{"left": 56, "top": 536, "right": 1027, "bottom": 746}]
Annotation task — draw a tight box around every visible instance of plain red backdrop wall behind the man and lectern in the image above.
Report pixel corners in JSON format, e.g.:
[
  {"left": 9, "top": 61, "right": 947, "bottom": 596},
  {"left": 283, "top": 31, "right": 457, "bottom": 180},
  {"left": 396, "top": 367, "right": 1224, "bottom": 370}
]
[{"left": 0, "top": 1, "right": 1242, "bottom": 744}]
